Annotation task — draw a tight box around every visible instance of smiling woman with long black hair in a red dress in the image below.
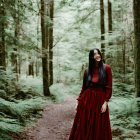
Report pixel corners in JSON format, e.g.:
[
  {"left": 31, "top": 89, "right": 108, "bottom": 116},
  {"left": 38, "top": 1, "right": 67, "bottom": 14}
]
[{"left": 69, "top": 48, "right": 112, "bottom": 140}]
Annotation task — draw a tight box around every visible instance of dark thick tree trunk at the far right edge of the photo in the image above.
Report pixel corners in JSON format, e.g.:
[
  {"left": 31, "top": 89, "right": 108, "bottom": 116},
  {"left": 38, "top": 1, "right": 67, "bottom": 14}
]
[{"left": 133, "top": 0, "right": 140, "bottom": 97}]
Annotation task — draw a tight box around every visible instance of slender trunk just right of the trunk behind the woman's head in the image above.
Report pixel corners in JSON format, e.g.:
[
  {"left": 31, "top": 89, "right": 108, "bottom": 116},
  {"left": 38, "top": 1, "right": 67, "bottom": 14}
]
[{"left": 108, "top": 0, "right": 112, "bottom": 45}]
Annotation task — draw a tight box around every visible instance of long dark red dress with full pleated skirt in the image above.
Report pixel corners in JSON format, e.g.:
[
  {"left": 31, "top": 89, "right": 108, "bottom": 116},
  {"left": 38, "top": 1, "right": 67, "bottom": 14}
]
[{"left": 69, "top": 64, "right": 112, "bottom": 140}]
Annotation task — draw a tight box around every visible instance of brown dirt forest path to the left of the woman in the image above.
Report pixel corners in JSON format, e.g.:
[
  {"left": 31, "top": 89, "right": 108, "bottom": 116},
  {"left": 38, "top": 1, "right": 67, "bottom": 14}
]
[{"left": 21, "top": 95, "right": 77, "bottom": 140}]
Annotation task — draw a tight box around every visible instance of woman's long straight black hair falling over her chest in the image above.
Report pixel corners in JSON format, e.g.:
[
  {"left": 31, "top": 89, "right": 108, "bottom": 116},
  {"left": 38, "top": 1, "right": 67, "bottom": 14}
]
[{"left": 86, "top": 48, "right": 105, "bottom": 86}]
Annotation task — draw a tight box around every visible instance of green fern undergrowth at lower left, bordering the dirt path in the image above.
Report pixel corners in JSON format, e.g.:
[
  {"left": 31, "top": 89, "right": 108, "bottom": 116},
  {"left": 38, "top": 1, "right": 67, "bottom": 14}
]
[{"left": 0, "top": 70, "right": 46, "bottom": 138}]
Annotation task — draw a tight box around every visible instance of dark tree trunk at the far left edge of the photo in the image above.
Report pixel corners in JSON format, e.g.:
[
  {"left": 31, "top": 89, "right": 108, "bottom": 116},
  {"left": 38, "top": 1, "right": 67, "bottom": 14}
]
[{"left": 0, "top": 0, "right": 6, "bottom": 70}]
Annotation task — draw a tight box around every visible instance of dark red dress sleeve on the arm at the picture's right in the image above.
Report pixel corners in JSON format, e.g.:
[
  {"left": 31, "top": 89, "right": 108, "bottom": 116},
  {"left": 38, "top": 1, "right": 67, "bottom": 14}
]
[{"left": 104, "top": 65, "right": 112, "bottom": 102}]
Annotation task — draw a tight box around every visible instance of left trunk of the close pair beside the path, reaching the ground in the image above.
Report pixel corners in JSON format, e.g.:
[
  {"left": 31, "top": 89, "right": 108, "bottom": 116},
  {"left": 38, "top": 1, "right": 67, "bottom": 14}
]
[{"left": 41, "top": 0, "right": 50, "bottom": 96}]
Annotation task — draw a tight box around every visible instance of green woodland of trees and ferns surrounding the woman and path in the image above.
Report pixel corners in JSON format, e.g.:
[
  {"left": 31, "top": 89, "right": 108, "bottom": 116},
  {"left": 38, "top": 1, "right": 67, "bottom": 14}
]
[{"left": 0, "top": 0, "right": 140, "bottom": 140}]
